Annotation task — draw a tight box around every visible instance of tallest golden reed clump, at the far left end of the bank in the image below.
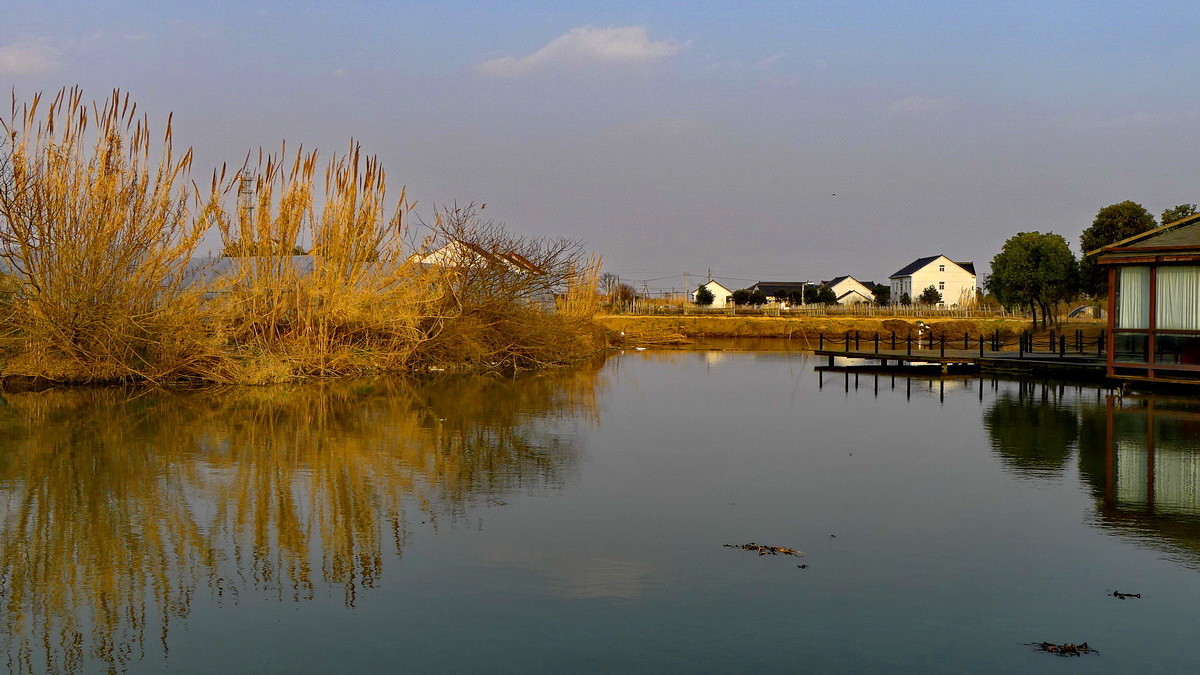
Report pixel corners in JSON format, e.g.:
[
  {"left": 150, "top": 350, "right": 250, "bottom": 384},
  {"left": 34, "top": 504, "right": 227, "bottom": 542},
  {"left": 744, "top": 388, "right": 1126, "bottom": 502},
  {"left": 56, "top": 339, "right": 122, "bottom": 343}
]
[{"left": 0, "top": 88, "right": 208, "bottom": 381}]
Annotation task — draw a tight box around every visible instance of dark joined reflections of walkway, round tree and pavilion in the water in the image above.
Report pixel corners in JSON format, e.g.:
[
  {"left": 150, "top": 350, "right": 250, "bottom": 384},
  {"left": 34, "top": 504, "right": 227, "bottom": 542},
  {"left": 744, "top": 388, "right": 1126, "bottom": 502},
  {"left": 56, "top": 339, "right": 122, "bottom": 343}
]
[{"left": 818, "top": 370, "right": 1200, "bottom": 568}]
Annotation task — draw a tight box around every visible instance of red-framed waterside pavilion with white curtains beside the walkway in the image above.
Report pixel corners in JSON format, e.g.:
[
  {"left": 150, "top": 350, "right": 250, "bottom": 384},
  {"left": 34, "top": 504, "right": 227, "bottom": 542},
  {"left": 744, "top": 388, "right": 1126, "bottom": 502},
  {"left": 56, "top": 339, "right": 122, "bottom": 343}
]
[{"left": 1087, "top": 214, "right": 1200, "bottom": 383}]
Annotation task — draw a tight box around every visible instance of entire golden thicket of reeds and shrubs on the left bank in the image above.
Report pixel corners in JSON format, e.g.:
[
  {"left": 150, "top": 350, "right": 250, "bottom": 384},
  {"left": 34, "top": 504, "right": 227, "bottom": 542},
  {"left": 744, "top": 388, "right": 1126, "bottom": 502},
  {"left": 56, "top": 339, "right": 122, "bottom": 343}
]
[{"left": 0, "top": 89, "right": 600, "bottom": 383}]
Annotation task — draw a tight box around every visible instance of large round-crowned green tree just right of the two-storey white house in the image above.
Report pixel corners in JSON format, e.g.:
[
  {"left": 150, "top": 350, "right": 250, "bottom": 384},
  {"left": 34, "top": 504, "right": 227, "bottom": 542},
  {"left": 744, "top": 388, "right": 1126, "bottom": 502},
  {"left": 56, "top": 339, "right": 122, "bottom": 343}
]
[{"left": 984, "top": 232, "right": 1080, "bottom": 328}]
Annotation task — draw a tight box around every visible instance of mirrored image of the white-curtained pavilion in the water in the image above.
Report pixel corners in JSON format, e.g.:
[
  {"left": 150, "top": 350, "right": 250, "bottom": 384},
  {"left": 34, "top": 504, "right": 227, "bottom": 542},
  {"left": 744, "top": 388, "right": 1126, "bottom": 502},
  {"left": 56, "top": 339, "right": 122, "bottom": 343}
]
[{"left": 1084, "top": 396, "right": 1200, "bottom": 563}]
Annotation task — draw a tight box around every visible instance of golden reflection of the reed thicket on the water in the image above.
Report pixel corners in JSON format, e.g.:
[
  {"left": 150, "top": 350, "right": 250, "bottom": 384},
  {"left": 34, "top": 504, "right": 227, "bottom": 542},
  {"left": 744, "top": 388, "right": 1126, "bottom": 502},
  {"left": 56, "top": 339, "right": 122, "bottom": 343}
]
[{"left": 0, "top": 363, "right": 601, "bottom": 671}]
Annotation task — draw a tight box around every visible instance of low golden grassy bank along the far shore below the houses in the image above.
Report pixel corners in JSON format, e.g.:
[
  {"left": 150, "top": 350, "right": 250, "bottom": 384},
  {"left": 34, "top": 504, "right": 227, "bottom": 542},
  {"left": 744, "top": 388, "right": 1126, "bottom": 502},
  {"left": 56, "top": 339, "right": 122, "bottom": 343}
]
[{"left": 596, "top": 315, "right": 1103, "bottom": 348}]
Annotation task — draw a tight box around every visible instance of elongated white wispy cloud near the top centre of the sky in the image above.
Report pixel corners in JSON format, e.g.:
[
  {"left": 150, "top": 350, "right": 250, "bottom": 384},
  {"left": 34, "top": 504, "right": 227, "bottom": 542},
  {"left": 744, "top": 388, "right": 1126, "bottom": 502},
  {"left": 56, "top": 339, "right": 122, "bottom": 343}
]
[{"left": 475, "top": 25, "right": 684, "bottom": 77}]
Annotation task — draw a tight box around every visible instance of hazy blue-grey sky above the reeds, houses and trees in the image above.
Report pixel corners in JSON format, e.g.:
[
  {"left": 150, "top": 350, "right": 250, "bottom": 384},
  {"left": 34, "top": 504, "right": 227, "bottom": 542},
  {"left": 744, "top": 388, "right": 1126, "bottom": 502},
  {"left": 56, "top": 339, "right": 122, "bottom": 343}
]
[{"left": 0, "top": 0, "right": 1200, "bottom": 291}]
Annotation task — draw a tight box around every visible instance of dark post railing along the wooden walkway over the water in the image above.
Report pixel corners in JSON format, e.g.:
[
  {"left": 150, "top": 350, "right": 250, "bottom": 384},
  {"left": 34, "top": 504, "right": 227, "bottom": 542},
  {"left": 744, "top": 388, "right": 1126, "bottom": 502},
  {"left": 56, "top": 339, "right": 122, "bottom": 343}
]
[{"left": 817, "top": 329, "right": 1108, "bottom": 358}]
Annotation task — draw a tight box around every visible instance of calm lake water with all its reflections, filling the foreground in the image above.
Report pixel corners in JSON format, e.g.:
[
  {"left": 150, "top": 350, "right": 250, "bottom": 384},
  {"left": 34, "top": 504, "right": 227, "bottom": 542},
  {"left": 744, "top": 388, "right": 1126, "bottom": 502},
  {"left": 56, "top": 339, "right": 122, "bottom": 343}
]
[{"left": 0, "top": 351, "right": 1200, "bottom": 673}]
